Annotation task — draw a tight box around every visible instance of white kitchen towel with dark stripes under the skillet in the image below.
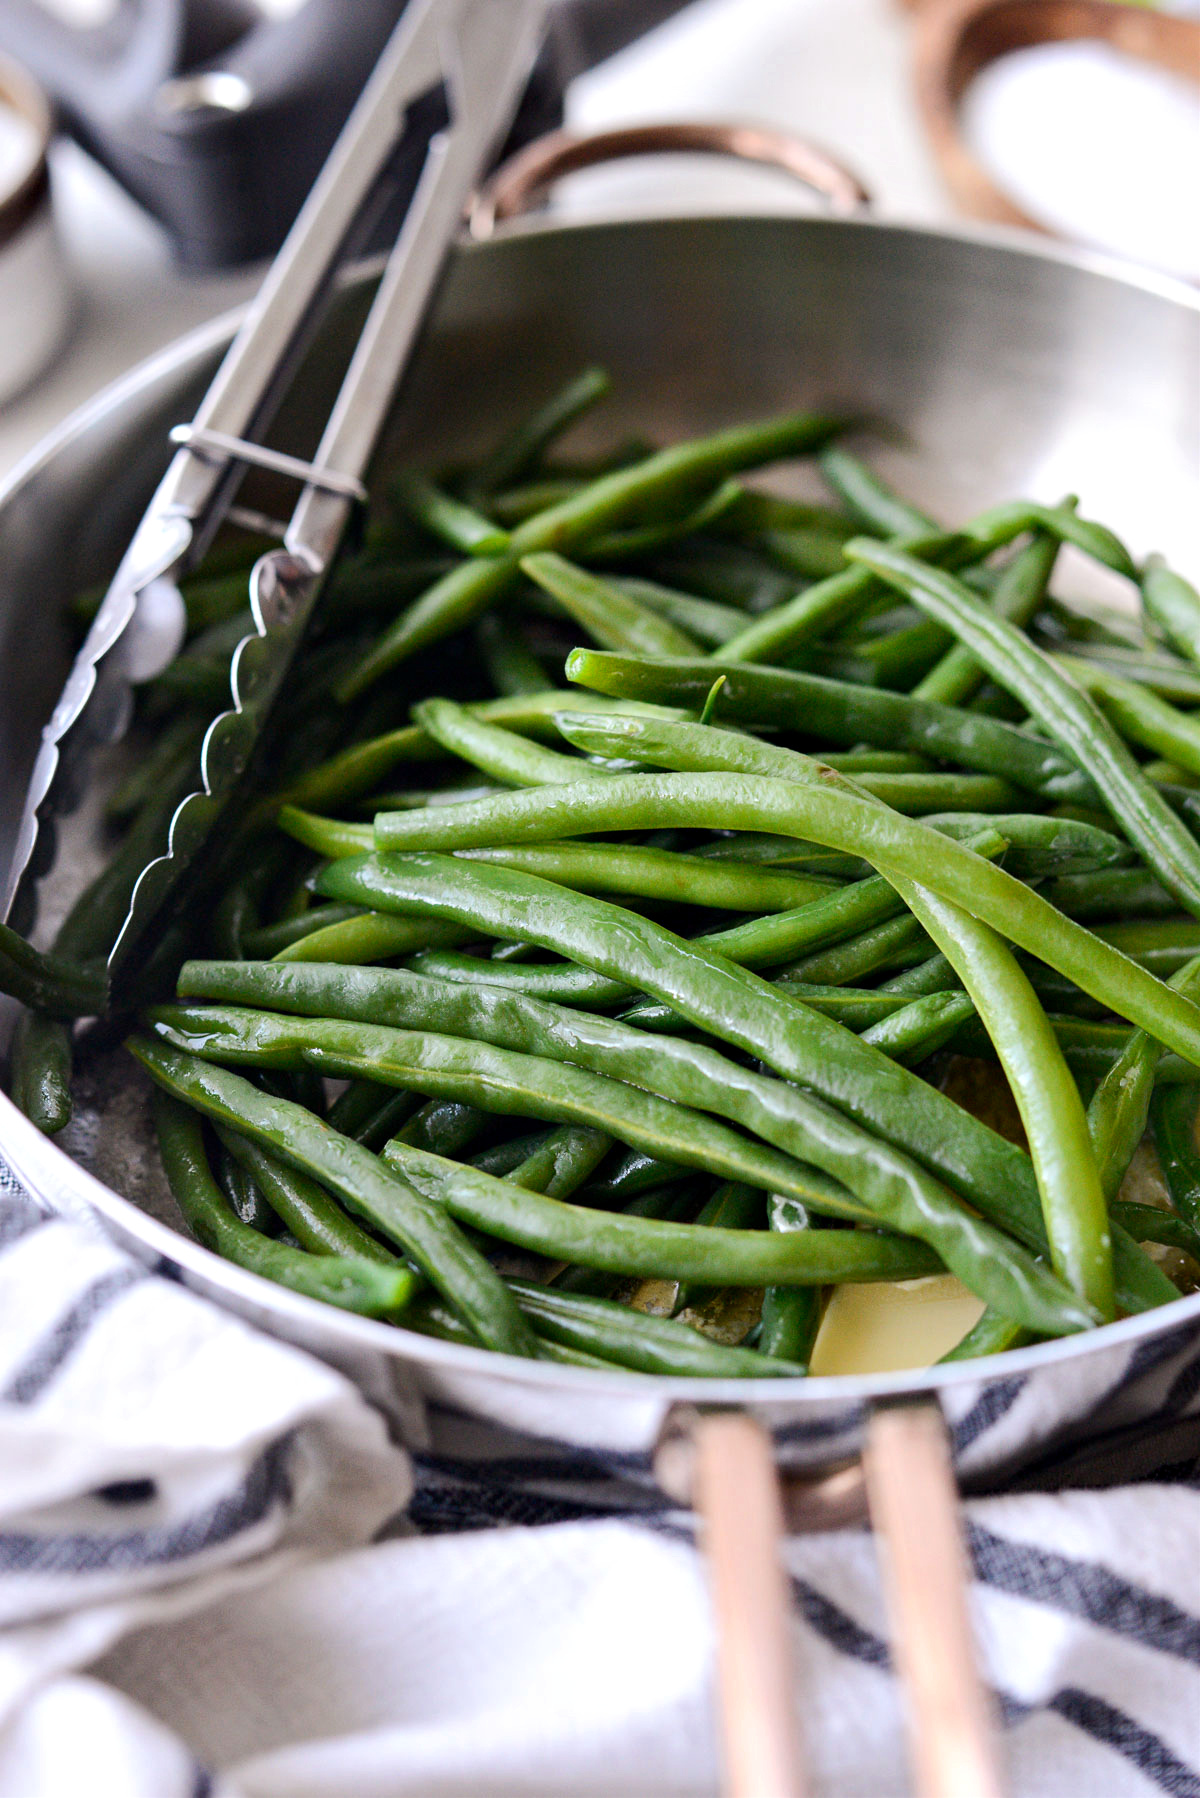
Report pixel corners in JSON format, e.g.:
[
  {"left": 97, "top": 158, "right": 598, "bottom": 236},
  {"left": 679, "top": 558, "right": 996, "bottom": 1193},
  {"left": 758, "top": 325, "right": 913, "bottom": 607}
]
[{"left": 0, "top": 1176, "right": 1200, "bottom": 1798}]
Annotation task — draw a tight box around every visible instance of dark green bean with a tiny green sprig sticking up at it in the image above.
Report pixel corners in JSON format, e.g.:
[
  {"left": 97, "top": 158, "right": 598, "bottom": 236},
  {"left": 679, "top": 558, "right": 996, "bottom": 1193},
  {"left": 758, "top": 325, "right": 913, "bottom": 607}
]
[{"left": 560, "top": 649, "right": 1094, "bottom": 800}]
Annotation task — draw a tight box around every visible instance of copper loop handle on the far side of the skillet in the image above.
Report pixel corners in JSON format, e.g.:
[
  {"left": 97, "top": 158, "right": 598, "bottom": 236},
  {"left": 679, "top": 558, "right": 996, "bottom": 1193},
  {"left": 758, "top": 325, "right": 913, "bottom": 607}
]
[{"left": 468, "top": 120, "right": 869, "bottom": 237}]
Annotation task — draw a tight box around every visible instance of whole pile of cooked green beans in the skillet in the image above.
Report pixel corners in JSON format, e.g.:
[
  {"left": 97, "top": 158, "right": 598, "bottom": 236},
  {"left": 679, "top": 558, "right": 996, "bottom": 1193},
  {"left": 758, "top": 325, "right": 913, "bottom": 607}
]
[{"left": 0, "top": 382, "right": 1200, "bottom": 1379}]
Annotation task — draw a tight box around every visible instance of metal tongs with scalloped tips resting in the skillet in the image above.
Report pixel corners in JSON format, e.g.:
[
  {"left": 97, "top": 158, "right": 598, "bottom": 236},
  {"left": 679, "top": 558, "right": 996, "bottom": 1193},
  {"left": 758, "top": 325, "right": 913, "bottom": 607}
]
[{"left": 4, "top": 0, "right": 545, "bottom": 985}]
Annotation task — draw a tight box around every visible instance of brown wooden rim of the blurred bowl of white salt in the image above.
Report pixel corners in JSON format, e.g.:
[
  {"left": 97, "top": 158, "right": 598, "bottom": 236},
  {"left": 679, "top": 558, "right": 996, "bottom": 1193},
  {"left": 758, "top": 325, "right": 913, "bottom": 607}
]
[{"left": 914, "top": 0, "right": 1200, "bottom": 232}]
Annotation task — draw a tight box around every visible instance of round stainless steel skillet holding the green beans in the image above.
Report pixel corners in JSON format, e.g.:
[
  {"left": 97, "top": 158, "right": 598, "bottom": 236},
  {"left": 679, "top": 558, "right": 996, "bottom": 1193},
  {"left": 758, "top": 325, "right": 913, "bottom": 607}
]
[{"left": 0, "top": 136, "right": 1200, "bottom": 1798}]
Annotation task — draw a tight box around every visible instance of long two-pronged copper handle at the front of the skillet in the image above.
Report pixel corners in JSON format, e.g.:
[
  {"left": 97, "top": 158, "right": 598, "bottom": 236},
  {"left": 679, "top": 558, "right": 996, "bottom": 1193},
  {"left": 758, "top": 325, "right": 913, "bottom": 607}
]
[{"left": 655, "top": 1401, "right": 1004, "bottom": 1798}]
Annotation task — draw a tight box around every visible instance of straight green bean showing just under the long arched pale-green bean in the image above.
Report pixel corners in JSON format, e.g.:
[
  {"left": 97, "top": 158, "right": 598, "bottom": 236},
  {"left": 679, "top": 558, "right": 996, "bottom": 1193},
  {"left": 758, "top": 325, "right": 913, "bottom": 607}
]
[{"left": 455, "top": 843, "right": 842, "bottom": 912}]
